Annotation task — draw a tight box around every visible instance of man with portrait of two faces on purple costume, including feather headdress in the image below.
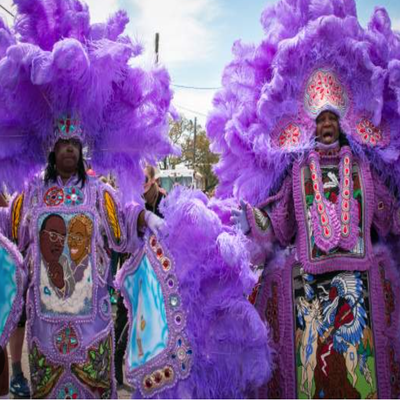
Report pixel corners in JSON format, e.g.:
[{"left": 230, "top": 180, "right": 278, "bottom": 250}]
[{"left": 0, "top": 0, "right": 173, "bottom": 398}]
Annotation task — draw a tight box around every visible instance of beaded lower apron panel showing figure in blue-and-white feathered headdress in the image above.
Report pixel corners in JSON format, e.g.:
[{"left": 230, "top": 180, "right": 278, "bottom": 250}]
[{"left": 292, "top": 265, "right": 377, "bottom": 399}]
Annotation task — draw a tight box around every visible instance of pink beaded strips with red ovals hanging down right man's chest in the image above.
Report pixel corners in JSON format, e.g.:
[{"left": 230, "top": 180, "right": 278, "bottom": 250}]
[{"left": 308, "top": 146, "right": 359, "bottom": 252}]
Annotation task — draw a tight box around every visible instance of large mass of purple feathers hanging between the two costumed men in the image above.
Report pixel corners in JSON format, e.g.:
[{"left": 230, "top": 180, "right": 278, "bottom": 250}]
[{"left": 136, "top": 187, "right": 272, "bottom": 399}]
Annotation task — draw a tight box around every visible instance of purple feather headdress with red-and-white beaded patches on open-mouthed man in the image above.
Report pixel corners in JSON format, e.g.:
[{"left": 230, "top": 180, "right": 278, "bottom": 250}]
[{"left": 207, "top": 0, "right": 400, "bottom": 204}]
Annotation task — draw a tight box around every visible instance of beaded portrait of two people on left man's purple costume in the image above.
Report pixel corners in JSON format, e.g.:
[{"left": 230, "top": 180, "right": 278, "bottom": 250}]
[{"left": 38, "top": 213, "right": 93, "bottom": 315}]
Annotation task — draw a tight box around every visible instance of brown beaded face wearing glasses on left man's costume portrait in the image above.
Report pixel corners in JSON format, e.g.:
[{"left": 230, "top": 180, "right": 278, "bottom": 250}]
[{"left": 39, "top": 215, "right": 67, "bottom": 263}]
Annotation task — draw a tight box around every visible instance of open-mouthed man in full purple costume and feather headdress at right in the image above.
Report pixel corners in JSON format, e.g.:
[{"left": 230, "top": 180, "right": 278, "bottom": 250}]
[{"left": 207, "top": 0, "right": 400, "bottom": 398}]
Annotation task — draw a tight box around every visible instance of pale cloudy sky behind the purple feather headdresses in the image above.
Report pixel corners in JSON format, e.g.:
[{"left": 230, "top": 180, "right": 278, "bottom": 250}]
[{"left": 0, "top": 0, "right": 400, "bottom": 125}]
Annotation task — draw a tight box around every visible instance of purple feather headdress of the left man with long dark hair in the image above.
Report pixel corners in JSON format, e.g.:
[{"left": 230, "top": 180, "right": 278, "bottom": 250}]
[{"left": 0, "top": 0, "right": 178, "bottom": 199}]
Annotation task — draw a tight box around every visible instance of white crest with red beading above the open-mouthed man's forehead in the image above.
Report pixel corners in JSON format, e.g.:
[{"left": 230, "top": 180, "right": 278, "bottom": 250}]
[{"left": 304, "top": 69, "right": 348, "bottom": 117}]
